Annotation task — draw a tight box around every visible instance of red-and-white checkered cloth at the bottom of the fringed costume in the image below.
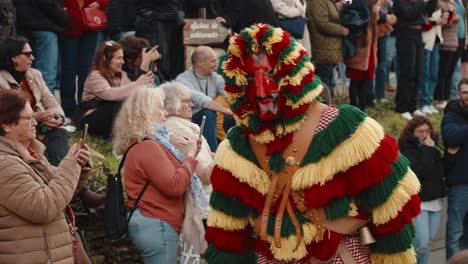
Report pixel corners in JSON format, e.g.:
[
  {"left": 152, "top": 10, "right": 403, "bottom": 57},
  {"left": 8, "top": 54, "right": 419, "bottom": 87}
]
[{"left": 257, "top": 234, "right": 371, "bottom": 264}]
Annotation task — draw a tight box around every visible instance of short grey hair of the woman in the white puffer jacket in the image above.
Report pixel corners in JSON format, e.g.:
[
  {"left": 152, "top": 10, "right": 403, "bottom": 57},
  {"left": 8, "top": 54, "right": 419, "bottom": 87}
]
[{"left": 159, "top": 81, "right": 190, "bottom": 115}]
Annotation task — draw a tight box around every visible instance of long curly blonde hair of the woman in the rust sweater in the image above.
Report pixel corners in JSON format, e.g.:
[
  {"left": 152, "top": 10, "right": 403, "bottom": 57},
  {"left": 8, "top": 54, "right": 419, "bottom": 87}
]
[{"left": 112, "top": 85, "right": 164, "bottom": 155}]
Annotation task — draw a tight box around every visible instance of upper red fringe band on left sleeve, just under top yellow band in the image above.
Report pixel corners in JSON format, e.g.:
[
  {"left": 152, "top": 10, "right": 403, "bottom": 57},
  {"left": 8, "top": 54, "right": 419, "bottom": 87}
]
[{"left": 211, "top": 166, "right": 265, "bottom": 214}]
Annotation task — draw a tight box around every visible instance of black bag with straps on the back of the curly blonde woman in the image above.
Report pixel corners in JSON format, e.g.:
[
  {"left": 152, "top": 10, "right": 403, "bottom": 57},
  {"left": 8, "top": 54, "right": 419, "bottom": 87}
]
[{"left": 104, "top": 139, "right": 149, "bottom": 243}]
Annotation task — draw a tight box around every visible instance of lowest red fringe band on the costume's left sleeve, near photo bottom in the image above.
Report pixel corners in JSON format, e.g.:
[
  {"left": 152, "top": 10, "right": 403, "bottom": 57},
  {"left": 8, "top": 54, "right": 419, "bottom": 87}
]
[{"left": 205, "top": 227, "right": 250, "bottom": 254}]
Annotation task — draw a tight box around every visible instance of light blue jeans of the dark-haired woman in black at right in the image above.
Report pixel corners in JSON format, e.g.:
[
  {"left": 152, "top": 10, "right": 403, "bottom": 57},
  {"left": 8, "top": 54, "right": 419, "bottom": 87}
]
[{"left": 414, "top": 210, "right": 441, "bottom": 264}]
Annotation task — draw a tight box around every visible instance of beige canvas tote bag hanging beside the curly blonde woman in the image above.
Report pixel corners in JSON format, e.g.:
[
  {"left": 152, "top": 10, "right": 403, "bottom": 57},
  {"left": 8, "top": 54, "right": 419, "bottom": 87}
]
[{"left": 177, "top": 191, "right": 208, "bottom": 264}]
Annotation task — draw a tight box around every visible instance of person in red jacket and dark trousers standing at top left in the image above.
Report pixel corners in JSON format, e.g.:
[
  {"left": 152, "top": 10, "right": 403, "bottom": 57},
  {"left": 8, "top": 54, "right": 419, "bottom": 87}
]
[{"left": 59, "top": 0, "right": 109, "bottom": 117}]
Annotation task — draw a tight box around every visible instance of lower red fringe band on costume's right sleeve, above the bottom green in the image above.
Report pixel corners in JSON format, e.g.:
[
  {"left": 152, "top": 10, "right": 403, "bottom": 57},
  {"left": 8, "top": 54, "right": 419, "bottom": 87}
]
[{"left": 372, "top": 194, "right": 421, "bottom": 237}]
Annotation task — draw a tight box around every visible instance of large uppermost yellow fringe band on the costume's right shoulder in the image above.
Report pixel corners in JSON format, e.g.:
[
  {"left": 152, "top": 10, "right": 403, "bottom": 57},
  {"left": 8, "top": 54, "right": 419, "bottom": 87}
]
[{"left": 292, "top": 117, "right": 385, "bottom": 190}]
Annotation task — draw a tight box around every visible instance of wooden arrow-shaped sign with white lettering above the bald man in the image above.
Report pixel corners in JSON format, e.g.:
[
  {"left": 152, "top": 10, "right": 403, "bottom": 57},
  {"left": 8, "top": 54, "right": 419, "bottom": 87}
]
[{"left": 184, "top": 19, "right": 229, "bottom": 45}]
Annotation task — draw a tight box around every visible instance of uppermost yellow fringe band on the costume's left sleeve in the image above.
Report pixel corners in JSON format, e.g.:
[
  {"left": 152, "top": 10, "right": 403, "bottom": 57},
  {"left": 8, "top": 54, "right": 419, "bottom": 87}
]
[{"left": 214, "top": 140, "right": 270, "bottom": 195}]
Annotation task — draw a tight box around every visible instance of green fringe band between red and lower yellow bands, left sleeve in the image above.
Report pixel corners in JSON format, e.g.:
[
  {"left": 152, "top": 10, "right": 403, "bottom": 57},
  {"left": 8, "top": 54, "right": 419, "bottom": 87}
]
[{"left": 210, "top": 191, "right": 252, "bottom": 218}]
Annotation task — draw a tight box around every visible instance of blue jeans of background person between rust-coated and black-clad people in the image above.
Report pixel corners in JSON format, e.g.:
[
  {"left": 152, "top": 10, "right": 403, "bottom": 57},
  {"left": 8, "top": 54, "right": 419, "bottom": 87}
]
[{"left": 371, "top": 36, "right": 388, "bottom": 100}]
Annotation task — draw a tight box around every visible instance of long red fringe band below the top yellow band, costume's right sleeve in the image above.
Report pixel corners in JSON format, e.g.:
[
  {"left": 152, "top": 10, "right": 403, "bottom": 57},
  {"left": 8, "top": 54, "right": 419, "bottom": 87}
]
[{"left": 305, "top": 135, "right": 398, "bottom": 207}]
